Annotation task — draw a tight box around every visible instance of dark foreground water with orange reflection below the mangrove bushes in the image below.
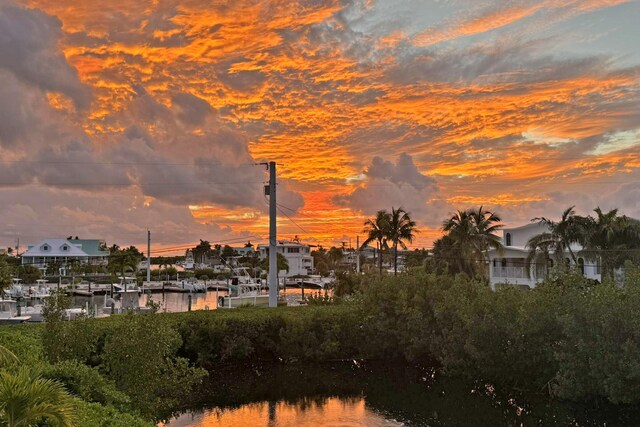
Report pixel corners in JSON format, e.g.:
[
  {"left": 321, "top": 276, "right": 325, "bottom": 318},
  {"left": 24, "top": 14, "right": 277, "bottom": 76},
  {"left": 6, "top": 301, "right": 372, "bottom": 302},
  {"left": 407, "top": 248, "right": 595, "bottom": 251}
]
[{"left": 159, "top": 362, "right": 640, "bottom": 427}]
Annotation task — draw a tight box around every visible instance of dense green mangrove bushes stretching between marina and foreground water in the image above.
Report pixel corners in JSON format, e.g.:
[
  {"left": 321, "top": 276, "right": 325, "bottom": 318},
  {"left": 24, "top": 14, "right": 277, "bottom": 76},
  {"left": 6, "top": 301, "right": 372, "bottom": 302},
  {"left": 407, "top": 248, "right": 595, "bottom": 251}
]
[{"left": 0, "top": 263, "right": 640, "bottom": 425}]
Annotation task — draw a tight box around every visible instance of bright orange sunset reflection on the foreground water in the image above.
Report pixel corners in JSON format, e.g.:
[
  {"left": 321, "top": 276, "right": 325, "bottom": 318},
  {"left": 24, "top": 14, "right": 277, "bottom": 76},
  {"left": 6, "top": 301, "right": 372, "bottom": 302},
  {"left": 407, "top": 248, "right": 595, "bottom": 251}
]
[{"left": 160, "top": 397, "right": 403, "bottom": 427}]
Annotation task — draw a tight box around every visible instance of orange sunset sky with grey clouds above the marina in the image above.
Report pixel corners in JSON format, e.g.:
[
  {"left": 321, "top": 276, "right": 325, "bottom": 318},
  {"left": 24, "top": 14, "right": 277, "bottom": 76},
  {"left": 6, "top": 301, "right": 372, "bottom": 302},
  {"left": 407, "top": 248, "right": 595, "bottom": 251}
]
[{"left": 0, "top": 0, "right": 640, "bottom": 252}]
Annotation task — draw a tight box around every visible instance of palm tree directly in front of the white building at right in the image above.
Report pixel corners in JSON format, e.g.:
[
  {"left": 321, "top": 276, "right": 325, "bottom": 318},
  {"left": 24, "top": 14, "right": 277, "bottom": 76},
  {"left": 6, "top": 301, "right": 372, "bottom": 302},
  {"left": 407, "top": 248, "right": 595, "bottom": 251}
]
[{"left": 525, "top": 206, "right": 585, "bottom": 280}]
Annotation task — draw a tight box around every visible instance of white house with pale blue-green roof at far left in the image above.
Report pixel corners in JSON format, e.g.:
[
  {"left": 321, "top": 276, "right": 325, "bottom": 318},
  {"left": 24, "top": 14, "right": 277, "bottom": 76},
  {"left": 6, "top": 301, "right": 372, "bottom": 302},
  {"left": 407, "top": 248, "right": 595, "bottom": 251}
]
[{"left": 22, "top": 239, "right": 109, "bottom": 275}]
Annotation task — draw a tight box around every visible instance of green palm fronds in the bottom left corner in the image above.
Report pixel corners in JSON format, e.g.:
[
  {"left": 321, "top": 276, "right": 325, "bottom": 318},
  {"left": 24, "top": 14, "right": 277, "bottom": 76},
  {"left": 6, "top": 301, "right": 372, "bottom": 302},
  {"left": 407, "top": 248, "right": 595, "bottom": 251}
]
[{"left": 0, "top": 367, "right": 76, "bottom": 427}]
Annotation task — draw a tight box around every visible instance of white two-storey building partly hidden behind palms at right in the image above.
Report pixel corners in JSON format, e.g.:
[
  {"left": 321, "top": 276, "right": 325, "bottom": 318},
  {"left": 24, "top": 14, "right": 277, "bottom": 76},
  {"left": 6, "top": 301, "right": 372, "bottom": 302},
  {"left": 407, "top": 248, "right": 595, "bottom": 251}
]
[{"left": 489, "top": 223, "right": 601, "bottom": 289}]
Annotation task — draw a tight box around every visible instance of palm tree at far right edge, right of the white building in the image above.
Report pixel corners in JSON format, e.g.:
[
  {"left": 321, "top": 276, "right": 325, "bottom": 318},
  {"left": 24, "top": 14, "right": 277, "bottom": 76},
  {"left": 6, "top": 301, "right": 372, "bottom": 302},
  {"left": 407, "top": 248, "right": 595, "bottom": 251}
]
[{"left": 580, "top": 207, "right": 640, "bottom": 279}]
